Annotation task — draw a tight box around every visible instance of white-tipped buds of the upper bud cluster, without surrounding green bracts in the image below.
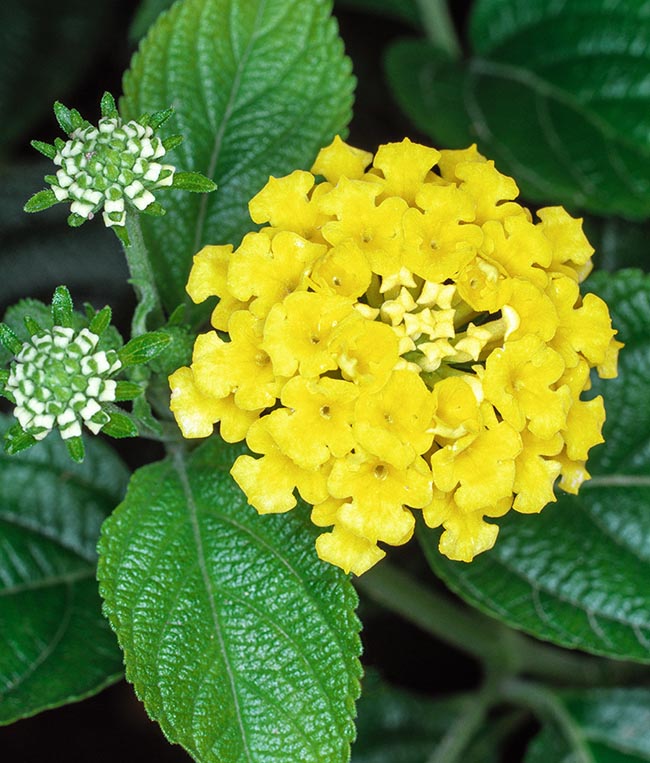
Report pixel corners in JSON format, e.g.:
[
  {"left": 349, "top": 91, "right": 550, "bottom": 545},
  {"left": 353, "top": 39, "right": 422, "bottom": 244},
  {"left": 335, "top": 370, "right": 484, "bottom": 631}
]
[{"left": 48, "top": 117, "right": 174, "bottom": 227}]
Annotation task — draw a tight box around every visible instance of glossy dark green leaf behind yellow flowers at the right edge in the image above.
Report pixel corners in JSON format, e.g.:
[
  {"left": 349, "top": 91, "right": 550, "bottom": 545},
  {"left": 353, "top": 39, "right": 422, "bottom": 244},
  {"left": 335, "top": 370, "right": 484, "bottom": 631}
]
[{"left": 419, "top": 270, "right": 650, "bottom": 662}]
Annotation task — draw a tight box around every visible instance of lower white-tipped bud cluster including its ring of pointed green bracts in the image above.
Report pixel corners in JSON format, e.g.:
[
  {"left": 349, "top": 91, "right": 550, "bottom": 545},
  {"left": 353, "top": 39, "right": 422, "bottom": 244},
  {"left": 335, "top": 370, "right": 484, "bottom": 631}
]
[{"left": 0, "top": 286, "right": 171, "bottom": 461}]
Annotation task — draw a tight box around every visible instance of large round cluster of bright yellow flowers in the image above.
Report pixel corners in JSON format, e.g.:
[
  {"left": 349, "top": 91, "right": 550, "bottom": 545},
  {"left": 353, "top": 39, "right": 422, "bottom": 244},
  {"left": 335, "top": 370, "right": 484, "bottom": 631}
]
[{"left": 170, "top": 138, "right": 621, "bottom": 574}]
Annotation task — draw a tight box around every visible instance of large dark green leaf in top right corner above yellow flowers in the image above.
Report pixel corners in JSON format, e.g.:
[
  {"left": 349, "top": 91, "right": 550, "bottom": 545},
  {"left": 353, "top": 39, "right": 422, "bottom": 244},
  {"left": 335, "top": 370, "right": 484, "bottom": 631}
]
[{"left": 388, "top": 0, "right": 650, "bottom": 218}]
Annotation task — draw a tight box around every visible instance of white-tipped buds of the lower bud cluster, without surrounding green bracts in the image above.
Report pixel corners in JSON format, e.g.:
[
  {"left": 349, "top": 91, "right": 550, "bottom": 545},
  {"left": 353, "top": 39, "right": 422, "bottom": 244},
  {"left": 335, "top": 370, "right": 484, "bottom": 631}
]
[{"left": 4, "top": 326, "right": 122, "bottom": 440}]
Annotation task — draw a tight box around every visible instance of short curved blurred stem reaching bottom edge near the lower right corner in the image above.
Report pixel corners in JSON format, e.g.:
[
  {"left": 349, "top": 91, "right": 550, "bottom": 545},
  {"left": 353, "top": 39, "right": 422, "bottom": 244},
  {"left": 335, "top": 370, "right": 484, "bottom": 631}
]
[{"left": 499, "top": 678, "right": 595, "bottom": 763}]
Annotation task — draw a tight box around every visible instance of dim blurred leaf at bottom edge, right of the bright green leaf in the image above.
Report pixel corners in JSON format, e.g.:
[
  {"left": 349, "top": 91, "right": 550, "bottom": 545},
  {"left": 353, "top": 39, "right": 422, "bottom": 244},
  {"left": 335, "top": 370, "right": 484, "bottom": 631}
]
[{"left": 352, "top": 673, "right": 499, "bottom": 763}]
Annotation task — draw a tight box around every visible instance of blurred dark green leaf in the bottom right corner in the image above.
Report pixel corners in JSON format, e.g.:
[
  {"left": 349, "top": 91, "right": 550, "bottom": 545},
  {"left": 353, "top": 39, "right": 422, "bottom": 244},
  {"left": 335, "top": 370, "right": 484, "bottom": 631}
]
[{"left": 525, "top": 689, "right": 650, "bottom": 763}]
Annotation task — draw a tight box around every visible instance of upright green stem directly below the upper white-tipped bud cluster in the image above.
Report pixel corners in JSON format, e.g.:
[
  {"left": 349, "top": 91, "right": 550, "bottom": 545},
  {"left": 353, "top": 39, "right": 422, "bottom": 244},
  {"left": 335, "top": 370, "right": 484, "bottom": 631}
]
[{"left": 122, "top": 210, "right": 165, "bottom": 336}]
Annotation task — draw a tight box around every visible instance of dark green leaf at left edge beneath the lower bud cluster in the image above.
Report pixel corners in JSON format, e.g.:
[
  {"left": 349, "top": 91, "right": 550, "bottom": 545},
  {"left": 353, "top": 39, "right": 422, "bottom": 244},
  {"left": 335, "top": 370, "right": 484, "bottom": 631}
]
[{"left": 0, "top": 416, "right": 128, "bottom": 723}]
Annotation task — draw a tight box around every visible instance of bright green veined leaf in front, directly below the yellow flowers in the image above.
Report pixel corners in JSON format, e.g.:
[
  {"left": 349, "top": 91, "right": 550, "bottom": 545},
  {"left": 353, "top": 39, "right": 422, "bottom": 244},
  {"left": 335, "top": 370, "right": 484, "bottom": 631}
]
[{"left": 98, "top": 438, "right": 360, "bottom": 763}]
